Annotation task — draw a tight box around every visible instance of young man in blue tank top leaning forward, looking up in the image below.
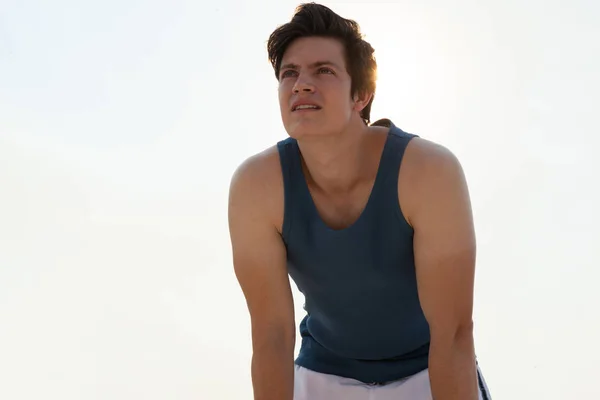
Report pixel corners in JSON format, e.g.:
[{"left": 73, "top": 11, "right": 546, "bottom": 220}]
[{"left": 229, "top": 4, "right": 490, "bottom": 400}]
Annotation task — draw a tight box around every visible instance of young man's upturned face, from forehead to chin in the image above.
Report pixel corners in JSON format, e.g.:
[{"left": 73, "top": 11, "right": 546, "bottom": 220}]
[{"left": 279, "top": 37, "right": 356, "bottom": 138}]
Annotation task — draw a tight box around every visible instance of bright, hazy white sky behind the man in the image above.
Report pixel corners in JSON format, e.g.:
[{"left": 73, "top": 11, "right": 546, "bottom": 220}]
[{"left": 0, "top": 0, "right": 600, "bottom": 400}]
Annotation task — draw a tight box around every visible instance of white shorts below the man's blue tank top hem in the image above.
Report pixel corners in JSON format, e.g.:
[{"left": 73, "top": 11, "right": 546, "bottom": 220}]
[{"left": 294, "top": 365, "right": 492, "bottom": 400}]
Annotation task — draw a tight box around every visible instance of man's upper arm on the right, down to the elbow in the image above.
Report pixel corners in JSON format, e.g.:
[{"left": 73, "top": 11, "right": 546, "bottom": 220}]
[{"left": 413, "top": 146, "right": 476, "bottom": 335}]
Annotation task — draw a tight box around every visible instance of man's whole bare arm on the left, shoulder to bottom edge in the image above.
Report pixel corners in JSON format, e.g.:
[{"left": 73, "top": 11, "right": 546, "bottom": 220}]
[{"left": 229, "top": 153, "right": 295, "bottom": 400}]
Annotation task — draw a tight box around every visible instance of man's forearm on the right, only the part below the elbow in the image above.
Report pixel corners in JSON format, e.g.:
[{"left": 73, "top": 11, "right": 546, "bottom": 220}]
[{"left": 429, "top": 332, "right": 479, "bottom": 400}]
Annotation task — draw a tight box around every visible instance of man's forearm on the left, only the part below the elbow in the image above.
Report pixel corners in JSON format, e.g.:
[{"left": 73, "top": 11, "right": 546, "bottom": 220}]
[{"left": 252, "top": 345, "right": 294, "bottom": 400}]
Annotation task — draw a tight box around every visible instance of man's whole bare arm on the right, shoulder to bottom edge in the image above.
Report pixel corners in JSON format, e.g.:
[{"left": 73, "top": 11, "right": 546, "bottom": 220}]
[{"left": 400, "top": 139, "right": 478, "bottom": 400}]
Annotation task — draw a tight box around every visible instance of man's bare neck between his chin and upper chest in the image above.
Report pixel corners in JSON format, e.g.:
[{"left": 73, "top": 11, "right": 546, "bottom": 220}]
[{"left": 298, "top": 121, "right": 369, "bottom": 193}]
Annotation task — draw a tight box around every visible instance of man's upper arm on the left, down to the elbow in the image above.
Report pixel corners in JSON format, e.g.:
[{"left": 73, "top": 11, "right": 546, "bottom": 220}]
[{"left": 229, "top": 158, "right": 295, "bottom": 339}]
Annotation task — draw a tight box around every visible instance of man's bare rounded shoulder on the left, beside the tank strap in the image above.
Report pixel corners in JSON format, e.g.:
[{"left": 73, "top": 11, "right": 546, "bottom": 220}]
[{"left": 229, "top": 145, "right": 283, "bottom": 228}]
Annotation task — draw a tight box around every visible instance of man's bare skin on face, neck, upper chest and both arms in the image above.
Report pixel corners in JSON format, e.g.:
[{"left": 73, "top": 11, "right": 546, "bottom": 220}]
[{"left": 229, "top": 37, "right": 477, "bottom": 400}]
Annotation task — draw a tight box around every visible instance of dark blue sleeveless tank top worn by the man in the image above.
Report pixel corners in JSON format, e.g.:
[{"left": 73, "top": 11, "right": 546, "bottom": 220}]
[{"left": 277, "top": 120, "right": 429, "bottom": 384}]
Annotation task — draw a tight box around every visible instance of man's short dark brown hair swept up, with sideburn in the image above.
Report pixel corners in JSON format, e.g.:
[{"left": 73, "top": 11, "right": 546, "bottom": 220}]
[{"left": 267, "top": 3, "right": 377, "bottom": 124}]
